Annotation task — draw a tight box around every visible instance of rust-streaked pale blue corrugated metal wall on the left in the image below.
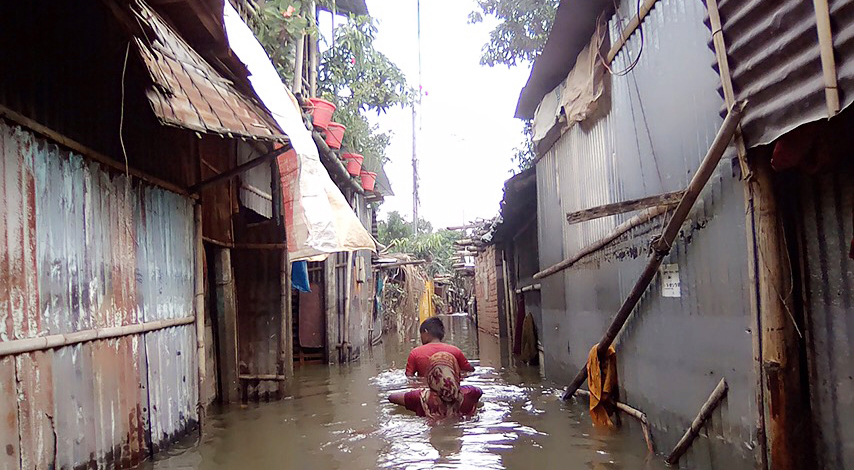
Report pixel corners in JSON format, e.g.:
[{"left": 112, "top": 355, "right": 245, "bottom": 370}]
[{"left": 0, "top": 121, "right": 198, "bottom": 468}]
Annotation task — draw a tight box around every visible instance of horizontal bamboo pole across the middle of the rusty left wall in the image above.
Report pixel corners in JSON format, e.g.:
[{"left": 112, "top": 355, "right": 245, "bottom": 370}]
[{"left": 0, "top": 316, "right": 196, "bottom": 357}]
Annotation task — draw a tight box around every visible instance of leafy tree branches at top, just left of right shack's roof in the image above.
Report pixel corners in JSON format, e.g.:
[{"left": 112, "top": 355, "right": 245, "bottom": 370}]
[{"left": 469, "top": 0, "right": 560, "bottom": 67}]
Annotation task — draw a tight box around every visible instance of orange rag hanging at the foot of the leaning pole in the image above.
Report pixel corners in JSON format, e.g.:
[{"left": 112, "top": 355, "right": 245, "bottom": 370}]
[{"left": 587, "top": 343, "right": 618, "bottom": 428}]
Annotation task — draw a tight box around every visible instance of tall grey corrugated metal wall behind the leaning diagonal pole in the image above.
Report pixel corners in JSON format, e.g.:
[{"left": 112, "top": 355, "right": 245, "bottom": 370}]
[{"left": 537, "top": 0, "right": 757, "bottom": 468}]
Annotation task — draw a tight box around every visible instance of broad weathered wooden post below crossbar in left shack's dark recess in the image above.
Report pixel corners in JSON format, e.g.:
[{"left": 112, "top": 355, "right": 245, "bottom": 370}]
[{"left": 214, "top": 248, "right": 240, "bottom": 403}]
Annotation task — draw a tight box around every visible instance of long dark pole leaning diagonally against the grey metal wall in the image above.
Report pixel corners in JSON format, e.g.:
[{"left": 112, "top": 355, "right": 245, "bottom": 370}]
[{"left": 563, "top": 102, "right": 745, "bottom": 400}]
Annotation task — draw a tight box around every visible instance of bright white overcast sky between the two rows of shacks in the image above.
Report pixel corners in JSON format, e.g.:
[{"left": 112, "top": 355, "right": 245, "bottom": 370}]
[{"left": 321, "top": 0, "right": 529, "bottom": 228}]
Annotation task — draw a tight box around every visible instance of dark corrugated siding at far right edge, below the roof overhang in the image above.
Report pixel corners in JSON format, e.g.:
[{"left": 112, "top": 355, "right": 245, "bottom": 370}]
[{"left": 798, "top": 164, "right": 854, "bottom": 469}]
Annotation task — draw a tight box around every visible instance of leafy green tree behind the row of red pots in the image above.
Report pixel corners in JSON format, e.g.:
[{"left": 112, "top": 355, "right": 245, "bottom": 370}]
[{"left": 318, "top": 16, "right": 412, "bottom": 167}]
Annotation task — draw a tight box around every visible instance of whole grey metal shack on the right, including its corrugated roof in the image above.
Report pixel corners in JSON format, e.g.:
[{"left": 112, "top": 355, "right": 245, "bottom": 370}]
[{"left": 517, "top": 0, "right": 854, "bottom": 469}]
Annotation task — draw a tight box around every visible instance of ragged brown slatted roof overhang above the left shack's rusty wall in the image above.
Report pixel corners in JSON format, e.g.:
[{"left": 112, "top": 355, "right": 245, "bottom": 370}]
[{"left": 132, "top": 0, "right": 286, "bottom": 140}]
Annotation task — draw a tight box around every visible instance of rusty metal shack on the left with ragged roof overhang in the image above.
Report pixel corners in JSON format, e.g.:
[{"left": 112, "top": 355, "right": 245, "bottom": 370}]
[{"left": 0, "top": 0, "right": 382, "bottom": 468}]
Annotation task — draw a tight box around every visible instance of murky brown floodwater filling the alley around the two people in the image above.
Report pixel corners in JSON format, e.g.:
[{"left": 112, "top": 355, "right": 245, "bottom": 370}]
[{"left": 146, "top": 316, "right": 665, "bottom": 470}]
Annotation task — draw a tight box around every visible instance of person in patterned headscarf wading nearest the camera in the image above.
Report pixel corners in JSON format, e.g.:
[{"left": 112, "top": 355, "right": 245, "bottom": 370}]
[{"left": 388, "top": 350, "right": 483, "bottom": 422}]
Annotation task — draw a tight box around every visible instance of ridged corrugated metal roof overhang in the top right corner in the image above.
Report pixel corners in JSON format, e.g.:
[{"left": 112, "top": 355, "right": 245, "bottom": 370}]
[{"left": 709, "top": 0, "right": 854, "bottom": 147}]
